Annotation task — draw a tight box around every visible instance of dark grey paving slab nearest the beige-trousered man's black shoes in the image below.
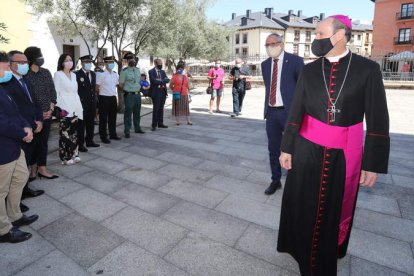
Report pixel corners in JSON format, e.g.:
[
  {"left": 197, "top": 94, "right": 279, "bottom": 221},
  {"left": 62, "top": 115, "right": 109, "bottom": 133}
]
[{"left": 39, "top": 214, "right": 124, "bottom": 268}]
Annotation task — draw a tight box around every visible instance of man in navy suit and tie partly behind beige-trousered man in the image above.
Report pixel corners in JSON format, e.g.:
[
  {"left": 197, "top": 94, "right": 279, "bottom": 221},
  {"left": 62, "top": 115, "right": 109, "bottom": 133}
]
[{"left": 3, "top": 51, "right": 44, "bottom": 201}]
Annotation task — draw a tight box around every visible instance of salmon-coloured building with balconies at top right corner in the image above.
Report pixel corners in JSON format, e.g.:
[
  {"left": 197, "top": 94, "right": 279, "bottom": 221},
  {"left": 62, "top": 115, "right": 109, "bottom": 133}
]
[{"left": 371, "top": 0, "right": 414, "bottom": 59}]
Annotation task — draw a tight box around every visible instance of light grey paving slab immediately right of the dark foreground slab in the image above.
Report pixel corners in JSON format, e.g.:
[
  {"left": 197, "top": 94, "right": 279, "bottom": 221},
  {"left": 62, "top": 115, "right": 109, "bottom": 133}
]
[{"left": 103, "top": 207, "right": 188, "bottom": 256}]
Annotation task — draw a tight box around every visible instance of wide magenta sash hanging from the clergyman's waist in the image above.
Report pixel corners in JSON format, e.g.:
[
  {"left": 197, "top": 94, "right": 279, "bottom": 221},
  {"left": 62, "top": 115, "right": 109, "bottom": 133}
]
[{"left": 299, "top": 114, "right": 364, "bottom": 245}]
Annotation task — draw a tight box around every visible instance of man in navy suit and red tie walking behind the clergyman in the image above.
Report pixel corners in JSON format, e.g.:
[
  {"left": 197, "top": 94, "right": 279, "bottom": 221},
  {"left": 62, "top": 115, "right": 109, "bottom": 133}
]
[{"left": 262, "top": 34, "right": 303, "bottom": 195}]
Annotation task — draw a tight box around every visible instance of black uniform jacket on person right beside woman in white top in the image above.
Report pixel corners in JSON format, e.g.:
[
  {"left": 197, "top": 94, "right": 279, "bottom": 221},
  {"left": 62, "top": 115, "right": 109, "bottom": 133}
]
[{"left": 75, "top": 69, "right": 96, "bottom": 110}]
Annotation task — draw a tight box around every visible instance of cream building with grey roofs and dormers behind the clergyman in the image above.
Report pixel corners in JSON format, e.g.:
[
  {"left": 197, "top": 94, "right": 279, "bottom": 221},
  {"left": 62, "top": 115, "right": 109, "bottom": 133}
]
[{"left": 225, "top": 8, "right": 372, "bottom": 60}]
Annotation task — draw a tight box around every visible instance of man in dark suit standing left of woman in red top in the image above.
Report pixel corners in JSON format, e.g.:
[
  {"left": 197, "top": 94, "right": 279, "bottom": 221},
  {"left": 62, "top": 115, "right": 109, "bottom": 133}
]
[{"left": 148, "top": 59, "right": 170, "bottom": 131}]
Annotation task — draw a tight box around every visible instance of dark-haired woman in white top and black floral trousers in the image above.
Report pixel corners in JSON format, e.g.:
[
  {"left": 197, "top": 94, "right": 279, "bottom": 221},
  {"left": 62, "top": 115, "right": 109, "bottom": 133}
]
[{"left": 53, "top": 54, "right": 83, "bottom": 165}]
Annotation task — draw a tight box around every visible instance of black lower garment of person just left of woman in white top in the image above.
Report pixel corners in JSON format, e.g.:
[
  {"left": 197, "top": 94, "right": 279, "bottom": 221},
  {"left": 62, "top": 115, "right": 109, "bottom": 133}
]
[{"left": 30, "top": 119, "right": 52, "bottom": 166}]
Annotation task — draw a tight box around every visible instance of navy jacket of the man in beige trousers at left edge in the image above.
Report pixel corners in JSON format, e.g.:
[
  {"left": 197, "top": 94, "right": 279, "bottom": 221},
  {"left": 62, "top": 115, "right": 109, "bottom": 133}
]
[{"left": 0, "top": 84, "right": 31, "bottom": 165}]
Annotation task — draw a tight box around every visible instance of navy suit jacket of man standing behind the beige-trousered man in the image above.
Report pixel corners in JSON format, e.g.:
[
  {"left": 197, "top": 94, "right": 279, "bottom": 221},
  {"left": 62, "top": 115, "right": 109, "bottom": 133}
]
[{"left": 2, "top": 76, "right": 43, "bottom": 130}]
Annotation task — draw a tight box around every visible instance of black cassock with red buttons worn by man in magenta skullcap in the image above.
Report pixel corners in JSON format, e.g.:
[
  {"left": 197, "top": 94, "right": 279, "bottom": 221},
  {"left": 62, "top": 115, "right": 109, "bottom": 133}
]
[{"left": 277, "top": 50, "right": 390, "bottom": 276}]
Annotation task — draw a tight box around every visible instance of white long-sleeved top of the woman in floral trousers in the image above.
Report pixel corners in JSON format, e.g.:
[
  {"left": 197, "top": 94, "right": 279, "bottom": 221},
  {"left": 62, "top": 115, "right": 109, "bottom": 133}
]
[{"left": 53, "top": 71, "right": 83, "bottom": 120}]
